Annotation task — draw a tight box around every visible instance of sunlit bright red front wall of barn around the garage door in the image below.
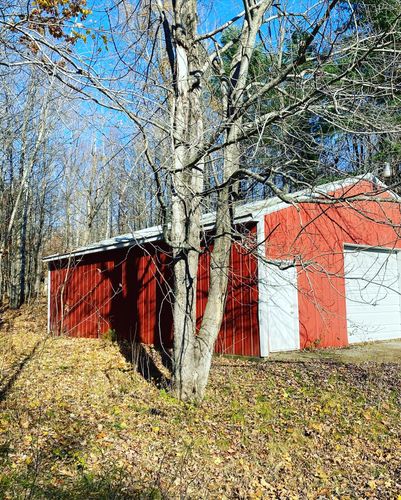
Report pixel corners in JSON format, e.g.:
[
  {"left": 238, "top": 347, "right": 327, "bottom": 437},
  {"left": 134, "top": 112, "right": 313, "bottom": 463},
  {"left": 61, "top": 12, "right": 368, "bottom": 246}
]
[{"left": 265, "top": 182, "right": 401, "bottom": 347}]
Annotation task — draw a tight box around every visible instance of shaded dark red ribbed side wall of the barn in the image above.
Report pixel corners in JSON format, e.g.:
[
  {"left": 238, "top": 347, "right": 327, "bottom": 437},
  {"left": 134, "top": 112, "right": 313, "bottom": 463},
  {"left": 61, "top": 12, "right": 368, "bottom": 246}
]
[{"left": 50, "top": 226, "right": 260, "bottom": 356}]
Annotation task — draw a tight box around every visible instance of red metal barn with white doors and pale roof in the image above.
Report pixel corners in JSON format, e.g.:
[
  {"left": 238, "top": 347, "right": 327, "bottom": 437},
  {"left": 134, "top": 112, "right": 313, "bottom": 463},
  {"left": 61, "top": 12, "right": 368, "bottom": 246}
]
[{"left": 45, "top": 175, "right": 401, "bottom": 356}]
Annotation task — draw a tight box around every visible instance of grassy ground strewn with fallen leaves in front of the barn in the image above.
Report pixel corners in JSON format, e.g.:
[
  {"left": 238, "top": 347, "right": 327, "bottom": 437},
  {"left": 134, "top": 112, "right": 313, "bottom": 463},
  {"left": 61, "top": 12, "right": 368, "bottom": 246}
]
[{"left": 0, "top": 309, "right": 401, "bottom": 499}]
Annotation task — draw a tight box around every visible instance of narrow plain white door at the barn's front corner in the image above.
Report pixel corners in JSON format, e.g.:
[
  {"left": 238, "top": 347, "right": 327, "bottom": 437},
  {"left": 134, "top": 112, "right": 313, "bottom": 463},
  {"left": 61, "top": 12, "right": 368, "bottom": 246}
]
[{"left": 265, "top": 264, "right": 300, "bottom": 352}]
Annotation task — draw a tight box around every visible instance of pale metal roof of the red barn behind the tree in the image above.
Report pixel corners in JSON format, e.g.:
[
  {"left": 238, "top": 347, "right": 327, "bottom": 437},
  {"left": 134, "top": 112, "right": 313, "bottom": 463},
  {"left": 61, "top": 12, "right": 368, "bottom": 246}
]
[{"left": 43, "top": 174, "right": 387, "bottom": 262}]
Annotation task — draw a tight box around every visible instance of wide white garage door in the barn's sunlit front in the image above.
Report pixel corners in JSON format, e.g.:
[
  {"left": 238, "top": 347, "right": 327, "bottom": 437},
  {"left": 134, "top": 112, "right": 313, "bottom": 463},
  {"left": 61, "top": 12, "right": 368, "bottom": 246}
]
[{"left": 344, "top": 248, "right": 401, "bottom": 343}]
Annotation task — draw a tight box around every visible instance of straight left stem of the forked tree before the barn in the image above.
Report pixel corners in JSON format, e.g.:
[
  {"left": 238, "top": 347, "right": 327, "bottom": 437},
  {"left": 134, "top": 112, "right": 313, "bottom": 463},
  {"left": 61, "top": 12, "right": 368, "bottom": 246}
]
[{"left": 170, "top": 0, "right": 203, "bottom": 401}]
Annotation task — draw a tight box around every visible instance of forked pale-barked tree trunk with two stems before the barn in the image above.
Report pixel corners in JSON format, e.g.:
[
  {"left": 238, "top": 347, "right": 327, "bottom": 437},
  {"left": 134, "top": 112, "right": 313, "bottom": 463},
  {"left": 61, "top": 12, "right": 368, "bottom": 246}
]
[{"left": 171, "top": 0, "right": 269, "bottom": 402}]
